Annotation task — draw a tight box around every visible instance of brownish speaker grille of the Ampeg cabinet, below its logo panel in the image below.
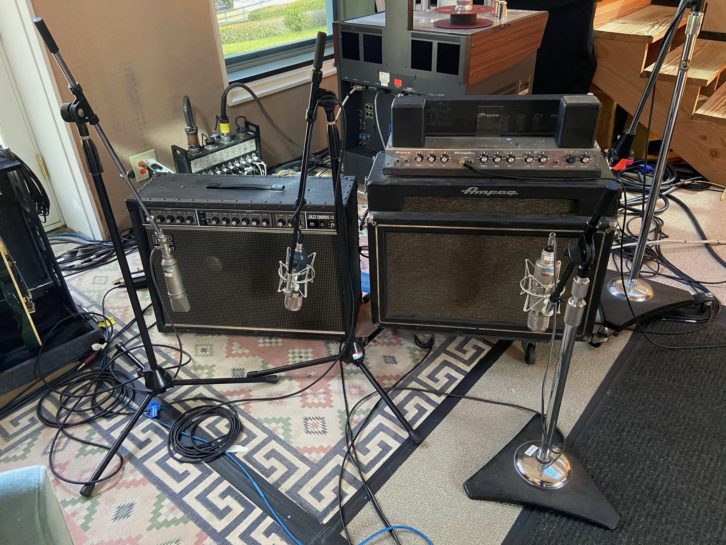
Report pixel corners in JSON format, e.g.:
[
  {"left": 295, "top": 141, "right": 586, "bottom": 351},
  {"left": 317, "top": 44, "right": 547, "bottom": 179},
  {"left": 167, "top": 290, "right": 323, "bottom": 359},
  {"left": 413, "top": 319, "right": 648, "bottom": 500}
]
[{"left": 372, "top": 225, "right": 609, "bottom": 337}]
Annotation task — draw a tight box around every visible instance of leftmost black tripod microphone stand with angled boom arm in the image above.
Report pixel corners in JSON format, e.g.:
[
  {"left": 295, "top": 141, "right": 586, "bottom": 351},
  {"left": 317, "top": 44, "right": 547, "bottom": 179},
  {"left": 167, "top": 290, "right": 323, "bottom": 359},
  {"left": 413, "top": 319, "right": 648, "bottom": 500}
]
[{"left": 33, "top": 17, "right": 277, "bottom": 497}]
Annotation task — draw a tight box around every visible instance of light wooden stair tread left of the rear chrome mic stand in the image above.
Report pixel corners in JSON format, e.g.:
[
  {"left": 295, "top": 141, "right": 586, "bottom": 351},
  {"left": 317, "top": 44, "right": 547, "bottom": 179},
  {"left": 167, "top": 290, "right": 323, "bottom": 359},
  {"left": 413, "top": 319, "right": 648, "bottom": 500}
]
[{"left": 595, "top": 5, "right": 686, "bottom": 44}]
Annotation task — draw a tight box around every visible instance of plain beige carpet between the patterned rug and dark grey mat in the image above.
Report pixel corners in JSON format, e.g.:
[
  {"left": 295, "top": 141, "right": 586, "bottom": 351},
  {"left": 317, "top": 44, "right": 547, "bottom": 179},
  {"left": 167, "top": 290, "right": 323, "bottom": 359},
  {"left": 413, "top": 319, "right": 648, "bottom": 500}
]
[{"left": 350, "top": 185, "right": 726, "bottom": 545}]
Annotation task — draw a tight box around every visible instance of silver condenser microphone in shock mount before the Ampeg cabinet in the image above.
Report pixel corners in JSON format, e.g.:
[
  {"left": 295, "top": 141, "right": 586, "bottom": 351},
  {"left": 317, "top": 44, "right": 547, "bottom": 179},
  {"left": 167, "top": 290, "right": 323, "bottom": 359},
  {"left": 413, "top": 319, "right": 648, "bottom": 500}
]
[{"left": 520, "top": 233, "right": 558, "bottom": 331}]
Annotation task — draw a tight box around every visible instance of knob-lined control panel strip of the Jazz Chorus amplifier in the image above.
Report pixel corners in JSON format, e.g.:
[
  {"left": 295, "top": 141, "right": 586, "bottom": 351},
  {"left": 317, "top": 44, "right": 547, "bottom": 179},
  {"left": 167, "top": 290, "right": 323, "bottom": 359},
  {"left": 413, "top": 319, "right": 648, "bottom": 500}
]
[{"left": 145, "top": 208, "right": 335, "bottom": 231}]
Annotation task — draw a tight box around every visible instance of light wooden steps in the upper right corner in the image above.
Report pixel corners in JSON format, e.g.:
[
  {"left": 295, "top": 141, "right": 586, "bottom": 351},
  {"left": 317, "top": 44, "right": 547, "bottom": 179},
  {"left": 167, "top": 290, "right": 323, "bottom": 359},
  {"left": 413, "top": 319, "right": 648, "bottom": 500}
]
[{"left": 594, "top": 0, "right": 726, "bottom": 185}]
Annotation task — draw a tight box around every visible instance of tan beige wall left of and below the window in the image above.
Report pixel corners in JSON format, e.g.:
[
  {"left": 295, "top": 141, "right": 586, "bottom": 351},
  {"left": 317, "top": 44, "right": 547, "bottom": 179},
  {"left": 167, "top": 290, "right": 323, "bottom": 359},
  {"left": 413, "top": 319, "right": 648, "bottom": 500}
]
[{"left": 30, "top": 0, "right": 336, "bottom": 231}]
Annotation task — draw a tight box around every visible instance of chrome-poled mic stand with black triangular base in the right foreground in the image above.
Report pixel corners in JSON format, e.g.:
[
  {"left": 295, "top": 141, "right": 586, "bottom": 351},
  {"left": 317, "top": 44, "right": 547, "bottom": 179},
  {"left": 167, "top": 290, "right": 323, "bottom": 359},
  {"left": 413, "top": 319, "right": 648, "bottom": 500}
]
[{"left": 464, "top": 187, "right": 620, "bottom": 530}]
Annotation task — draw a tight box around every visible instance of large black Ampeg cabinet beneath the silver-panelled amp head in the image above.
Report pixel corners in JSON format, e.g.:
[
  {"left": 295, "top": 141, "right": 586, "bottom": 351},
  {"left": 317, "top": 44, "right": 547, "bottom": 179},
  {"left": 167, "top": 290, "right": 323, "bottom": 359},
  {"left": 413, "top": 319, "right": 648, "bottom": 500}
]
[{"left": 368, "top": 157, "right": 617, "bottom": 340}]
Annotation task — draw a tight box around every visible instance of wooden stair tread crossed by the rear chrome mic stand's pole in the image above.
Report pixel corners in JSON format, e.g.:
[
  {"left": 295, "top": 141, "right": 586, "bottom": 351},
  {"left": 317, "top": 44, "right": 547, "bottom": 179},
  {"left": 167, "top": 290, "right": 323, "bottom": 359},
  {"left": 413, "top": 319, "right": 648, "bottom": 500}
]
[{"left": 641, "top": 39, "right": 726, "bottom": 87}]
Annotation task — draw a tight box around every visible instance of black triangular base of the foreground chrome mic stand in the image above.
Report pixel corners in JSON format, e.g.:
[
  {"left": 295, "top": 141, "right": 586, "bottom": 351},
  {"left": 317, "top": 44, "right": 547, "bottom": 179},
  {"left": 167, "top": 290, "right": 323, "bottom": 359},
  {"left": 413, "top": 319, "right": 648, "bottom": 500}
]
[{"left": 464, "top": 415, "right": 620, "bottom": 530}]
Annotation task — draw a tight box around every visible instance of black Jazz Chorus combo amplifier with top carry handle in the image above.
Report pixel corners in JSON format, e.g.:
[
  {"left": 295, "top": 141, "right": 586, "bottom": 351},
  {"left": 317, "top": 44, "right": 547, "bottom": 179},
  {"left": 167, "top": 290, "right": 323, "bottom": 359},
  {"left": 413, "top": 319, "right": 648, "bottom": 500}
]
[{"left": 127, "top": 174, "right": 360, "bottom": 337}]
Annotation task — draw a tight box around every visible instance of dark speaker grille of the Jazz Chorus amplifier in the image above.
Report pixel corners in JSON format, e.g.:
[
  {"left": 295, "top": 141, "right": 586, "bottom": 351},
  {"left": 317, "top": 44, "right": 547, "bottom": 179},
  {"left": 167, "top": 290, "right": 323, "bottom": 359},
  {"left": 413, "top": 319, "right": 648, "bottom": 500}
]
[{"left": 147, "top": 227, "right": 352, "bottom": 335}]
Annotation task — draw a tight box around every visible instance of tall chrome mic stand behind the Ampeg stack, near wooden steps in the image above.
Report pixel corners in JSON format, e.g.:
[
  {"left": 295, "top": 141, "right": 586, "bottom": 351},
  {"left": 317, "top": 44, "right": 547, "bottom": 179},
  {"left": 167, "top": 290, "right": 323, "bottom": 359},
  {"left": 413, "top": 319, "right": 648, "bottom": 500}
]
[{"left": 601, "top": 0, "right": 704, "bottom": 329}]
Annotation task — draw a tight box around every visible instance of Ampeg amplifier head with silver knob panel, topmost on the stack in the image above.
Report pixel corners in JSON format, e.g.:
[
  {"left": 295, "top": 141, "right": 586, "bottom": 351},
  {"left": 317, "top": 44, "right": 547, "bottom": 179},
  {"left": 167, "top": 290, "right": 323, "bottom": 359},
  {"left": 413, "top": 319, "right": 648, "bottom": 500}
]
[{"left": 383, "top": 95, "right": 603, "bottom": 178}]
